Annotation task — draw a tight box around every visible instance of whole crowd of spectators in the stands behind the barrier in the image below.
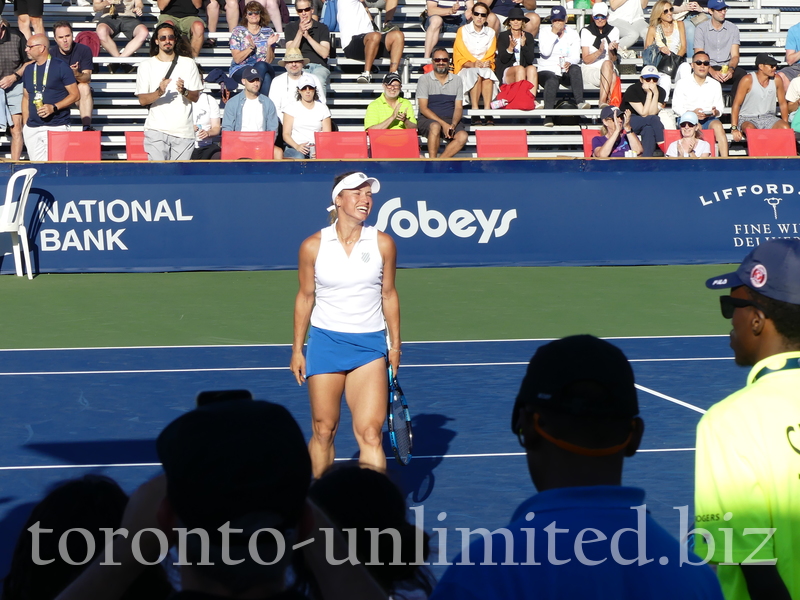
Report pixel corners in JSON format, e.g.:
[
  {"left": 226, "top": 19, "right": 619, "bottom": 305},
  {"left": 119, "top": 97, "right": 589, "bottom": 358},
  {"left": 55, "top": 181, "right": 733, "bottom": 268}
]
[{"left": 0, "top": 0, "right": 800, "bottom": 161}]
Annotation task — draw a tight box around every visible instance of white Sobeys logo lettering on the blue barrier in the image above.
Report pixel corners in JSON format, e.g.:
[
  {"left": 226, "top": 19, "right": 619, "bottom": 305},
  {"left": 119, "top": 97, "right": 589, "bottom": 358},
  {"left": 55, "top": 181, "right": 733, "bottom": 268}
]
[{"left": 376, "top": 198, "right": 517, "bottom": 244}]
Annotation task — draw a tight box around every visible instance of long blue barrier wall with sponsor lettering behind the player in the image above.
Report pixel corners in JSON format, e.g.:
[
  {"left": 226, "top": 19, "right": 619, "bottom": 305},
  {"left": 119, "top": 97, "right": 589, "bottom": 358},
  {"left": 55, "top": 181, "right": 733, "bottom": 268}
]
[{"left": 0, "top": 159, "right": 800, "bottom": 273}]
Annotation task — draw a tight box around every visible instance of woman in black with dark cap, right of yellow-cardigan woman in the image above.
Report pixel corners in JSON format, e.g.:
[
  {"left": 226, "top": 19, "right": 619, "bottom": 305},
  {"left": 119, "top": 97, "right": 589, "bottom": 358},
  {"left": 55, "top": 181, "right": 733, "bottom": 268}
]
[{"left": 494, "top": 8, "right": 536, "bottom": 91}]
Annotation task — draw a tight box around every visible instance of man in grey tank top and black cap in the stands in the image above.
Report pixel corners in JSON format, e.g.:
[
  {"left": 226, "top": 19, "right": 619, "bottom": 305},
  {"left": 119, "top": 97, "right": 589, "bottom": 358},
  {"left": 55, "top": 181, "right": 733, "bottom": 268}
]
[{"left": 731, "top": 52, "right": 789, "bottom": 142}]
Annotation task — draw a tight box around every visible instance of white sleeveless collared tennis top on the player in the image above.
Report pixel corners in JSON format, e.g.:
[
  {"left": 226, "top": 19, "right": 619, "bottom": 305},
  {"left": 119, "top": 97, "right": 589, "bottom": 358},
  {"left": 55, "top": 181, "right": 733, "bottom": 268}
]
[{"left": 311, "top": 225, "right": 384, "bottom": 333}]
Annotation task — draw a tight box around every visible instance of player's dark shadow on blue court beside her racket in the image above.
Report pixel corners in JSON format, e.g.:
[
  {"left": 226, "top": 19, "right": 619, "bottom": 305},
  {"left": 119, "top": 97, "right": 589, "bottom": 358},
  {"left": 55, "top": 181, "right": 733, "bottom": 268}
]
[{"left": 383, "top": 414, "right": 456, "bottom": 503}]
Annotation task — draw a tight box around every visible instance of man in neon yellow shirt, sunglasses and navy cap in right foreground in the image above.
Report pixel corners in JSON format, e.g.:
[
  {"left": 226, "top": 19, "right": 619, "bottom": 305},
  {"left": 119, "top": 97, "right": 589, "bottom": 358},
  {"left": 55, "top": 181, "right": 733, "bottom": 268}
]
[{"left": 695, "top": 239, "right": 800, "bottom": 600}]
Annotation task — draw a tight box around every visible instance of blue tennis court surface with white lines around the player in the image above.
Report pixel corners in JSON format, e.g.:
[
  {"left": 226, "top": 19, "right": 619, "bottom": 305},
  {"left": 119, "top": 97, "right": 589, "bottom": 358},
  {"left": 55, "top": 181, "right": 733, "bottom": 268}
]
[{"left": 0, "top": 336, "right": 746, "bottom": 575}]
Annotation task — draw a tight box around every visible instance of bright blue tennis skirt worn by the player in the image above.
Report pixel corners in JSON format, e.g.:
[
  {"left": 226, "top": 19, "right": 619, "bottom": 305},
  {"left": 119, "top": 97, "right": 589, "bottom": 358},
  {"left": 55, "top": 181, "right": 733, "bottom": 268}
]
[{"left": 306, "top": 326, "right": 387, "bottom": 377}]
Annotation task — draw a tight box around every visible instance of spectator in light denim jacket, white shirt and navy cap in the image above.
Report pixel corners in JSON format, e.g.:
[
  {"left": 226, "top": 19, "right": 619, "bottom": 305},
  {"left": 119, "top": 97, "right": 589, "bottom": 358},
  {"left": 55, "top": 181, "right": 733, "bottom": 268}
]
[{"left": 222, "top": 67, "right": 283, "bottom": 160}]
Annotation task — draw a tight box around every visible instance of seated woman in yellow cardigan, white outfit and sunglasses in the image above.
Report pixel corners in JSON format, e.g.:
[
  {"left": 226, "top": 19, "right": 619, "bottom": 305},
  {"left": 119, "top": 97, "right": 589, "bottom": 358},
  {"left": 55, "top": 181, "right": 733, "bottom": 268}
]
[{"left": 453, "top": 2, "right": 499, "bottom": 125}]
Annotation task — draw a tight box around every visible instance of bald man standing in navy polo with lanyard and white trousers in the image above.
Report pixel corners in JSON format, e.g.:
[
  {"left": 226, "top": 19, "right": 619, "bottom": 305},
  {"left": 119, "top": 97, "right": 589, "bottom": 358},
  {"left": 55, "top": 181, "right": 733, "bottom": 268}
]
[{"left": 22, "top": 34, "right": 80, "bottom": 161}]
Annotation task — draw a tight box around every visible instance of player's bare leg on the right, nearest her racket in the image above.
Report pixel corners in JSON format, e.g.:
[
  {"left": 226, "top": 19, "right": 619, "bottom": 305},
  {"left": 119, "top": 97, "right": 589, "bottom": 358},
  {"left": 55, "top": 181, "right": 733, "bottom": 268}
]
[{"left": 344, "top": 358, "right": 389, "bottom": 470}]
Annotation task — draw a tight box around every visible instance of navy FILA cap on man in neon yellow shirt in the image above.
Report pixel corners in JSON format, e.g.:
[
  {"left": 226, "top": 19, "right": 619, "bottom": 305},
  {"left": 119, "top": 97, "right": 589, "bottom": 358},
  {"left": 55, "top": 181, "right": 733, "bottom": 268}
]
[{"left": 706, "top": 240, "right": 800, "bottom": 304}]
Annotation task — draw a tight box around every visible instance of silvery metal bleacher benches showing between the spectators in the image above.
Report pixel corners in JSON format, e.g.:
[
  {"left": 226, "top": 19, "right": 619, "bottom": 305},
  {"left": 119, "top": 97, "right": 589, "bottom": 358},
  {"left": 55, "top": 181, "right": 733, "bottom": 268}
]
[{"left": 0, "top": 0, "right": 788, "bottom": 160}]
